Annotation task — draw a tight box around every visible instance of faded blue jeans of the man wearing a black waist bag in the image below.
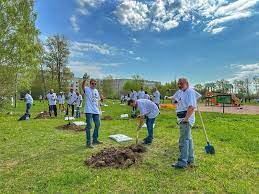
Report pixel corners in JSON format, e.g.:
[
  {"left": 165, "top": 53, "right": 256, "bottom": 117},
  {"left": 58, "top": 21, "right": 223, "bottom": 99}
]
[{"left": 178, "top": 123, "right": 194, "bottom": 166}]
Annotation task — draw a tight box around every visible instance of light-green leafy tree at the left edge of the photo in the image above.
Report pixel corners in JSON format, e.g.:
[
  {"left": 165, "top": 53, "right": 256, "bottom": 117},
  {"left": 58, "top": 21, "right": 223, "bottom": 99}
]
[{"left": 0, "top": 0, "right": 42, "bottom": 106}]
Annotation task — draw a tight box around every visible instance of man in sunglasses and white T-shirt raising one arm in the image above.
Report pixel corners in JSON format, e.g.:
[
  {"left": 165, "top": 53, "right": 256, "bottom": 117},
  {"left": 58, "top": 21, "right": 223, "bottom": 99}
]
[{"left": 82, "top": 79, "right": 102, "bottom": 148}]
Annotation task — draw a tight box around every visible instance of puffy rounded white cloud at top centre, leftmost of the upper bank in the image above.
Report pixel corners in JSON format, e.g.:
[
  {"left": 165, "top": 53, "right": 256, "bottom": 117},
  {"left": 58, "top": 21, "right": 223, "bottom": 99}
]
[{"left": 114, "top": 0, "right": 150, "bottom": 31}]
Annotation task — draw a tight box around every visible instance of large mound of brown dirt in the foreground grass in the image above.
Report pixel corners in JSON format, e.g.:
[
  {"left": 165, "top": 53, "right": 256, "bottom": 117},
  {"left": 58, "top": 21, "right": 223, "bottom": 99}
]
[{"left": 85, "top": 145, "right": 147, "bottom": 168}]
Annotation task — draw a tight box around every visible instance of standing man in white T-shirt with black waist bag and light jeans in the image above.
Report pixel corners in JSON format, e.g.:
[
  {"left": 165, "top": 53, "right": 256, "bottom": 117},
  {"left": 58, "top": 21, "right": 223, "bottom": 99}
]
[{"left": 166, "top": 78, "right": 201, "bottom": 168}]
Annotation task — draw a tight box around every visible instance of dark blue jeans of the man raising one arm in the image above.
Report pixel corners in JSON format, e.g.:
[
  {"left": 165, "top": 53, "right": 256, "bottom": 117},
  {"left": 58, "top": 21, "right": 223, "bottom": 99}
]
[{"left": 85, "top": 113, "right": 100, "bottom": 145}]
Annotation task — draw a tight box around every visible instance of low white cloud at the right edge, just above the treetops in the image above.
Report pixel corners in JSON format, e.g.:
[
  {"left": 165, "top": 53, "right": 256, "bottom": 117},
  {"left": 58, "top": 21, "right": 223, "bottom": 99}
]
[{"left": 229, "top": 63, "right": 259, "bottom": 81}]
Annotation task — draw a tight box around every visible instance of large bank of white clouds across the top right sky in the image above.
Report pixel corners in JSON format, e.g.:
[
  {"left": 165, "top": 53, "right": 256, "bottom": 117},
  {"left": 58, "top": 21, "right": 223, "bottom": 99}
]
[{"left": 115, "top": 0, "right": 259, "bottom": 34}]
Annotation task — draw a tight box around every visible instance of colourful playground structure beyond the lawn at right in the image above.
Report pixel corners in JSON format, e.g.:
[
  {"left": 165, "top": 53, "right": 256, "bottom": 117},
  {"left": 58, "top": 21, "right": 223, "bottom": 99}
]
[{"left": 205, "top": 83, "right": 241, "bottom": 107}]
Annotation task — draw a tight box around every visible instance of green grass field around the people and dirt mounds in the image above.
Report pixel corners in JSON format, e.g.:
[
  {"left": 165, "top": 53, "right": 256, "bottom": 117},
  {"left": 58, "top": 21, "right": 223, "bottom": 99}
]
[{"left": 0, "top": 101, "right": 259, "bottom": 193}]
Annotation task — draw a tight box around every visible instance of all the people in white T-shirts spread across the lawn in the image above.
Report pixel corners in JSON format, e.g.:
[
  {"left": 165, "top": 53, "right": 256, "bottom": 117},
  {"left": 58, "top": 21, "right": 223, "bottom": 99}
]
[{"left": 26, "top": 78, "right": 201, "bottom": 168}]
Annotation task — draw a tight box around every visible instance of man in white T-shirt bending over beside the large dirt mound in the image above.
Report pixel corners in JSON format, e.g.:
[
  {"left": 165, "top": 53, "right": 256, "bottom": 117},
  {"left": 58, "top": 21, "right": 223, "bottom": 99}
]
[{"left": 128, "top": 99, "right": 159, "bottom": 145}]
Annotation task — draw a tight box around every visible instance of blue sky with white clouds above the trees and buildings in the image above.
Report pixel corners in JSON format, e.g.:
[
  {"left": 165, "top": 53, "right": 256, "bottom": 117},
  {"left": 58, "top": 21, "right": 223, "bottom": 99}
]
[{"left": 35, "top": 0, "right": 259, "bottom": 84}]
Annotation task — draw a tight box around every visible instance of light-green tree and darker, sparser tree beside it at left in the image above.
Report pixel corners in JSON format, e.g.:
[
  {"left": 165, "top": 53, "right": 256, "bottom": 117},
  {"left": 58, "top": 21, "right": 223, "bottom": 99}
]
[{"left": 0, "top": 0, "right": 73, "bottom": 108}]
